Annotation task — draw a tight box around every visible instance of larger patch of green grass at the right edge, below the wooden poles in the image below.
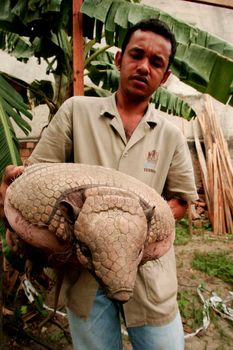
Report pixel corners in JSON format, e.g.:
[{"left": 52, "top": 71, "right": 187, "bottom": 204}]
[{"left": 192, "top": 251, "right": 233, "bottom": 284}]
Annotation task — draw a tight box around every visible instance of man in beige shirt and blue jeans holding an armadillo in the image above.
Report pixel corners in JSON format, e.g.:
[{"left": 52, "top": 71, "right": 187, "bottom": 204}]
[{"left": 1, "top": 19, "right": 197, "bottom": 350}]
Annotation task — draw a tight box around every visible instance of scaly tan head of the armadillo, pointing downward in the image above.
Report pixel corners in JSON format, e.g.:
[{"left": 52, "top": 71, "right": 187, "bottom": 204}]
[{"left": 59, "top": 189, "right": 147, "bottom": 302}]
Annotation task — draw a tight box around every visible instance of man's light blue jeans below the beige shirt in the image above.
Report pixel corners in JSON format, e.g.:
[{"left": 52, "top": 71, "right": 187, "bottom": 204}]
[{"left": 67, "top": 290, "right": 184, "bottom": 350}]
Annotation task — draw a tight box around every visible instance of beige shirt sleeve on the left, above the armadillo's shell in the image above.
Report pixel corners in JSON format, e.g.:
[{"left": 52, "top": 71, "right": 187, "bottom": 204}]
[{"left": 28, "top": 98, "right": 73, "bottom": 163}]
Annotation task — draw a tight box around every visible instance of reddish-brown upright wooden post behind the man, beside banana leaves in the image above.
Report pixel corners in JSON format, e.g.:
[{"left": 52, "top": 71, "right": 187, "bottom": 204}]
[{"left": 73, "top": 0, "right": 84, "bottom": 96}]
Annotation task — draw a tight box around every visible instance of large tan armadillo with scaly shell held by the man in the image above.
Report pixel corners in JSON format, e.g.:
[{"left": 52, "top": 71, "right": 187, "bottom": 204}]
[{"left": 4, "top": 163, "right": 175, "bottom": 302}]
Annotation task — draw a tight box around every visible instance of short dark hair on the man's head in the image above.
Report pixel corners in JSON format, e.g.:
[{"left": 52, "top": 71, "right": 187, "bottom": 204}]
[{"left": 121, "top": 18, "right": 177, "bottom": 69}]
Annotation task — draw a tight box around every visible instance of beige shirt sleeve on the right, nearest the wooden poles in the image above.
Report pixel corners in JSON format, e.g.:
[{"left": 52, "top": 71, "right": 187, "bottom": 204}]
[{"left": 163, "top": 135, "right": 198, "bottom": 201}]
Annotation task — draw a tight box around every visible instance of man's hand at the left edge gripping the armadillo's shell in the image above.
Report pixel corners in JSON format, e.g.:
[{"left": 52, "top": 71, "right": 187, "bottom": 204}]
[{"left": 0, "top": 165, "right": 24, "bottom": 219}]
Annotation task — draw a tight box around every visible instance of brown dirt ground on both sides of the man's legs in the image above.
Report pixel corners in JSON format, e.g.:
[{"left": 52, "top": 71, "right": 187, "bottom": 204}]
[{"left": 0, "top": 224, "right": 233, "bottom": 350}]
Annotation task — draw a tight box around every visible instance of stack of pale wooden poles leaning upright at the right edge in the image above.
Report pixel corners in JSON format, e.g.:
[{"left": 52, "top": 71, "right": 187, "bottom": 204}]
[{"left": 193, "top": 96, "right": 233, "bottom": 234}]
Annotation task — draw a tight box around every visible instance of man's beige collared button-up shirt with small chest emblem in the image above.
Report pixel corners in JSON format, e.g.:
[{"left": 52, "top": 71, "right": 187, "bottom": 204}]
[{"left": 29, "top": 94, "right": 198, "bottom": 326}]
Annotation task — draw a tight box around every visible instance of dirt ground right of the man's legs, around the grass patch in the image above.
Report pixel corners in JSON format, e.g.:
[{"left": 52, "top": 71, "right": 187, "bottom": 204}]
[{"left": 175, "top": 233, "right": 233, "bottom": 350}]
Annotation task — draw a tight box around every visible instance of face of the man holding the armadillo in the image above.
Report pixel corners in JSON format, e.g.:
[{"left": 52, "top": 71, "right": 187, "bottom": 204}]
[{"left": 115, "top": 30, "right": 171, "bottom": 100}]
